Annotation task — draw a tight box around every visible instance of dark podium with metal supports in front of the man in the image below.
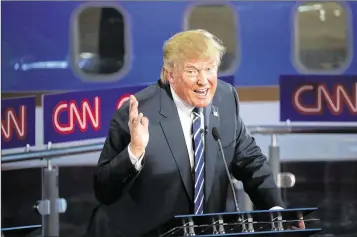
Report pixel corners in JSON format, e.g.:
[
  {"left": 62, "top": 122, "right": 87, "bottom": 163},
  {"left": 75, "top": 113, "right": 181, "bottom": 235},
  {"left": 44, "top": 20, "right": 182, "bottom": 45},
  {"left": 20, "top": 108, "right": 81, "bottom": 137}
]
[{"left": 160, "top": 208, "right": 322, "bottom": 237}]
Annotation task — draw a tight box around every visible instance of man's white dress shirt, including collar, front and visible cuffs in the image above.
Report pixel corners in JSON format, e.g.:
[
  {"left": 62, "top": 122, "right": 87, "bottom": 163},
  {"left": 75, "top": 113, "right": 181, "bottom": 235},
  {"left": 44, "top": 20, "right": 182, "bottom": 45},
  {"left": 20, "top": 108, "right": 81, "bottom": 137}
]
[{"left": 128, "top": 88, "right": 283, "bottom": 210}]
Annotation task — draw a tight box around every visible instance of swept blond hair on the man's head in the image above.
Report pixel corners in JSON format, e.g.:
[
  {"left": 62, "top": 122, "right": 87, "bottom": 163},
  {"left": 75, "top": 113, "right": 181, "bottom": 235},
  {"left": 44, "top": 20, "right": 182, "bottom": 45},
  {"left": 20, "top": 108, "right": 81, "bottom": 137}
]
[{"left": 160, "top": 29, "right": 226, "bottom": 83}]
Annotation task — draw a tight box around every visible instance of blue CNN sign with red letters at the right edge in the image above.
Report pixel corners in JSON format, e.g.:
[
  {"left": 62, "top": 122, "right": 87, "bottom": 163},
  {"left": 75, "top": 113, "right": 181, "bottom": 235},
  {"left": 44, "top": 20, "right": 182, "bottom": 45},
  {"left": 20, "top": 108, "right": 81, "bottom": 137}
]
[{"left": 279, "top": 75, "right": 357, "bottom": 122}]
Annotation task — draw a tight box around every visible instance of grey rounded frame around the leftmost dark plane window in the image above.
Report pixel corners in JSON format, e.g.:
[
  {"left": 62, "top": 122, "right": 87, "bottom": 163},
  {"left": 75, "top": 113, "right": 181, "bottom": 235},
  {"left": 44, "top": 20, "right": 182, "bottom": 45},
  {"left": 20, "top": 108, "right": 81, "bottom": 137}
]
[{"left": 69, "top": 2, "right": 132, "bottom": 83}]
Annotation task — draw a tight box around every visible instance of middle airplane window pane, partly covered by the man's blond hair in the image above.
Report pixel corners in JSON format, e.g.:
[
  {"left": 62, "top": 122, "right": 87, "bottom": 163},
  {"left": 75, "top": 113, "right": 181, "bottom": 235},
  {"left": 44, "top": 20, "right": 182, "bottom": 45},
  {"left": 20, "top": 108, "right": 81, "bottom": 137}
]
[{"left": 185, "top": 4, "right": 238, "bottom": 72}]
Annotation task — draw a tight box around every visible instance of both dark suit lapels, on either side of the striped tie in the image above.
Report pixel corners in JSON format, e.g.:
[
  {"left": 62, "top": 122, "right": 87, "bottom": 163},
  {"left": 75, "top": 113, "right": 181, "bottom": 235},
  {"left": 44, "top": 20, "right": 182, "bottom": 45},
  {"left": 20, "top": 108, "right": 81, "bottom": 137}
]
[{"left": 156, "top": 82, "right": 220, "bottom": 202}]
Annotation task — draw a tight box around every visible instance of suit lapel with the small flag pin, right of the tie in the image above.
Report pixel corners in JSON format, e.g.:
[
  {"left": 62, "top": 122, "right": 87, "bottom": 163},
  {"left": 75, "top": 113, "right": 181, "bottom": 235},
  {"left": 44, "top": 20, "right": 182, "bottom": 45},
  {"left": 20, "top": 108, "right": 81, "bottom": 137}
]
[{"left": 205, "top": 102, "right": 219, "bottom": 202}]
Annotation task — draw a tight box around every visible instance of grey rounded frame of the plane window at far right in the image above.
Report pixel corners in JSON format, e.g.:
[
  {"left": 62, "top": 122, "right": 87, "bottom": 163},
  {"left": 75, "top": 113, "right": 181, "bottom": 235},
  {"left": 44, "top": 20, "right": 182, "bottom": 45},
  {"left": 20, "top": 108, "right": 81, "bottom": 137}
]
[{"left": 291, "top": 1, "right": 353, "bottom": 75}]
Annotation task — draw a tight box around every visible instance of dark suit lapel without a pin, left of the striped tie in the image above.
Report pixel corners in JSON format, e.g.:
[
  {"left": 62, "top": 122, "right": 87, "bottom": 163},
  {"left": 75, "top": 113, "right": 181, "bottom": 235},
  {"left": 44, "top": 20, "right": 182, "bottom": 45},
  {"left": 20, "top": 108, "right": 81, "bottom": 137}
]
[{"left": 160, "top": 85, "right": 193, "bottom": 200}]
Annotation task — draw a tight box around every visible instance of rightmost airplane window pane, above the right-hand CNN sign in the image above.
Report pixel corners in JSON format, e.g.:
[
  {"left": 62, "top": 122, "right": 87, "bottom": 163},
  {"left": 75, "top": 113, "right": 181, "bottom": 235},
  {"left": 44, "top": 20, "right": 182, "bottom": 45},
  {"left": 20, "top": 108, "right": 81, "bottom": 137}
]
[{"left": 295, "top": 2, "right": 350, "bottom": 72}]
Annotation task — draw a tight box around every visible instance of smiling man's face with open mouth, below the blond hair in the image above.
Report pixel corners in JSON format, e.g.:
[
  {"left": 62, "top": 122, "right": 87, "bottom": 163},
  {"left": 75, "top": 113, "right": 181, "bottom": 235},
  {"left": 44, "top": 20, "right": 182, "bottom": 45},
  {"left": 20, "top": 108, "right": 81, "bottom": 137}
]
[{"left": 168, "top": 59, "right": 218, "bottom": 108}]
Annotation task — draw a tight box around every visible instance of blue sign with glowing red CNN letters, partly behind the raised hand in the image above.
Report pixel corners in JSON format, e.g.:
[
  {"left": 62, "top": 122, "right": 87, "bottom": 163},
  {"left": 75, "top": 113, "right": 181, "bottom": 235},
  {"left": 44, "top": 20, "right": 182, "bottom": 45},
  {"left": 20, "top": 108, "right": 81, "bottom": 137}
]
[{"left": 43, "top": 85, "right": 146, "bottom": 143}]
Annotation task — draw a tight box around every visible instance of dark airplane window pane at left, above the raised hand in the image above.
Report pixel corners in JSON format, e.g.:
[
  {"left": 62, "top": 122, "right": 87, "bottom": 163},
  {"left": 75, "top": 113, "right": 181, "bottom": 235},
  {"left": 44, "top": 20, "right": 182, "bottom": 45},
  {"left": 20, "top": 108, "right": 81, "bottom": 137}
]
[{"left": 75, "top": 6, "right": 127, "bottom": 76}]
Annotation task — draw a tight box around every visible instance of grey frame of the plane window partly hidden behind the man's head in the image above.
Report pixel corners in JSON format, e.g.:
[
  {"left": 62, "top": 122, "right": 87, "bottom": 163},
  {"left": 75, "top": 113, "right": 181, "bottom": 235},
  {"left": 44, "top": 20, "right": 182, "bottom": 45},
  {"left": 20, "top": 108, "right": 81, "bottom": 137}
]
[{"left": 182, "top": 0, "right": 242, "bottom": 76}]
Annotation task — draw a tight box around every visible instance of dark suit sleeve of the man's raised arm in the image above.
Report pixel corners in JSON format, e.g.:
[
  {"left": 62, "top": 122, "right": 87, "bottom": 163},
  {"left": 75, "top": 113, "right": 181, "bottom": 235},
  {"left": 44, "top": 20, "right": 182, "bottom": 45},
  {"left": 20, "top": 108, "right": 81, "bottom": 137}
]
[{"left": 94, "top": 111, "right": 144, "bottom": 205}]
